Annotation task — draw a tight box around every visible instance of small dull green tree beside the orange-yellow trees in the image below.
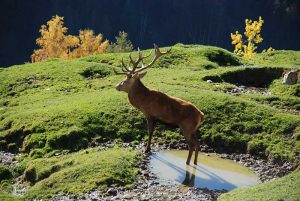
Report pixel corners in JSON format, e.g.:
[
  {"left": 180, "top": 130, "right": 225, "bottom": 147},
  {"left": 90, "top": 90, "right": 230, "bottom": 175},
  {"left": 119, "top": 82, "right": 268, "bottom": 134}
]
[{"left": 107, "top": 31, "right": 133, "bottom": 52}]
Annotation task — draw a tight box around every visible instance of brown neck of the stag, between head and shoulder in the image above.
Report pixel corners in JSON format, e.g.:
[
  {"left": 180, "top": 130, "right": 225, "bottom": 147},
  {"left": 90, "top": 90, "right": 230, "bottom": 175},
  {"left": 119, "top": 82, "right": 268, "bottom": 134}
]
[{"left": 128, "top": 80, "right": 149, "bottom": 108}]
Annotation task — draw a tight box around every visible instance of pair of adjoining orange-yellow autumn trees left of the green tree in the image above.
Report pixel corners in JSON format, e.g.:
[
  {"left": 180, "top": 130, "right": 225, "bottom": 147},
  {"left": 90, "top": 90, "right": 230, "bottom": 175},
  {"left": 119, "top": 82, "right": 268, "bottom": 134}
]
[{"left": 31, "top": 15, "right": 109, "bottom": 62}]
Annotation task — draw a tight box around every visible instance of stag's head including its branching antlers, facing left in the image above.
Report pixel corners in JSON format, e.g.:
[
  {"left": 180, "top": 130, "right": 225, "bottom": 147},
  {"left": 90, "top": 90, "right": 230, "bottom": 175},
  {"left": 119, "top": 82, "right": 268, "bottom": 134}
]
[{"left": 113, "top": 44, "right": 171, "bottom": 93}]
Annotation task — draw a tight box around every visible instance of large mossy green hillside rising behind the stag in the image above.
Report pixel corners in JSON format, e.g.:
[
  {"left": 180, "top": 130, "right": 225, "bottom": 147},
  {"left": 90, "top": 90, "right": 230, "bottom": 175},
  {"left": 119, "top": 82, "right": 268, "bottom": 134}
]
[{"left": 0, "top": 44, "right": 300, "bottom": 161}]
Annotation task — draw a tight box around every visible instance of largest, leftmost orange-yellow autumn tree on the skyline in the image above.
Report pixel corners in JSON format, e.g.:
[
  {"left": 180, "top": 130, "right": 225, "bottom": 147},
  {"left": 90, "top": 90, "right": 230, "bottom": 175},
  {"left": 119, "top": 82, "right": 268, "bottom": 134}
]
[{"left": 31, "top": 15, "right": 79, "bottom": 62}]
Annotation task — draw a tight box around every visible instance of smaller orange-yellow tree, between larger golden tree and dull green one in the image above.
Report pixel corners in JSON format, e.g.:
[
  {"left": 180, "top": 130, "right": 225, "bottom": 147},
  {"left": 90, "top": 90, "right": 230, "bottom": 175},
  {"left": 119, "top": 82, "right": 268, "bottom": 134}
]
[{"left": 70, "top": 29, "right": 109, "bottom": 58}]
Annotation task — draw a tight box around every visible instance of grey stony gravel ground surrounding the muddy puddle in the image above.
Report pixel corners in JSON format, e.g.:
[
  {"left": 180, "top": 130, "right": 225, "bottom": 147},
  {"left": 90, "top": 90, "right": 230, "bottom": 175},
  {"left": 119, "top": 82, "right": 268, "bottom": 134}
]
[{"left": 48, "top": 140, "right": 296, "bottom": 201}]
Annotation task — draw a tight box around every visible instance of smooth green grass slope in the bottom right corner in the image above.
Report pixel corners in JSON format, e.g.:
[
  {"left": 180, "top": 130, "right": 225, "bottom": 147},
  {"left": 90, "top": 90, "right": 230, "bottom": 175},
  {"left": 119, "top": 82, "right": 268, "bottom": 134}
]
[{"left": 218, "top": 170, "right": 300, "bottom": 201}]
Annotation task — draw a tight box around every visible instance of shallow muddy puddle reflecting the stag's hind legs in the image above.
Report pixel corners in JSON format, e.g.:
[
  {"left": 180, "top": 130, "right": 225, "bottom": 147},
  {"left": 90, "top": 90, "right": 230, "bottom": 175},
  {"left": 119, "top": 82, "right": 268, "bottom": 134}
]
[{"left": 150, "top": 150, "right": 259, "bottom": 190}]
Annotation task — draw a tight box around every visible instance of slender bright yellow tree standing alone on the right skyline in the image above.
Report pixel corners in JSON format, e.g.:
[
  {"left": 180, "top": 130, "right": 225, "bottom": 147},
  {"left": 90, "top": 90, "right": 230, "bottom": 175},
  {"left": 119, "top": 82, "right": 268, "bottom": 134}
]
[{"left": 231, "top": 17, "right": 264, "bottom": 58}]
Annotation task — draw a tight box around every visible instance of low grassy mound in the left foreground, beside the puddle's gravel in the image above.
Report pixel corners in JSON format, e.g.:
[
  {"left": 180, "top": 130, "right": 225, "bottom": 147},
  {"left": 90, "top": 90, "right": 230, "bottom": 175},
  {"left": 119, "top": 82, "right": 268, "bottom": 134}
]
[{"left": 22, "top": 148, "right": 140, "bottom": 200}]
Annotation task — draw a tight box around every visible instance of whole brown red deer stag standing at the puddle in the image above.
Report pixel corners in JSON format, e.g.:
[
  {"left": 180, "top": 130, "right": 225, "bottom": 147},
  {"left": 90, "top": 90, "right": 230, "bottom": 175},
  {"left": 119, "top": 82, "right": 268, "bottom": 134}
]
[{"left": 114, "top": 44, "right": 204, "bottom": 164}]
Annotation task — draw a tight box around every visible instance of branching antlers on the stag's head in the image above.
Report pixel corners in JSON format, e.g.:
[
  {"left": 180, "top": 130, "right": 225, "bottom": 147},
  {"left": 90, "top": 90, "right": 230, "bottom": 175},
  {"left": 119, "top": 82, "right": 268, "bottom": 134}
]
[{"left": 113, "top": 44, "right": 172, "bottom": 75}]
